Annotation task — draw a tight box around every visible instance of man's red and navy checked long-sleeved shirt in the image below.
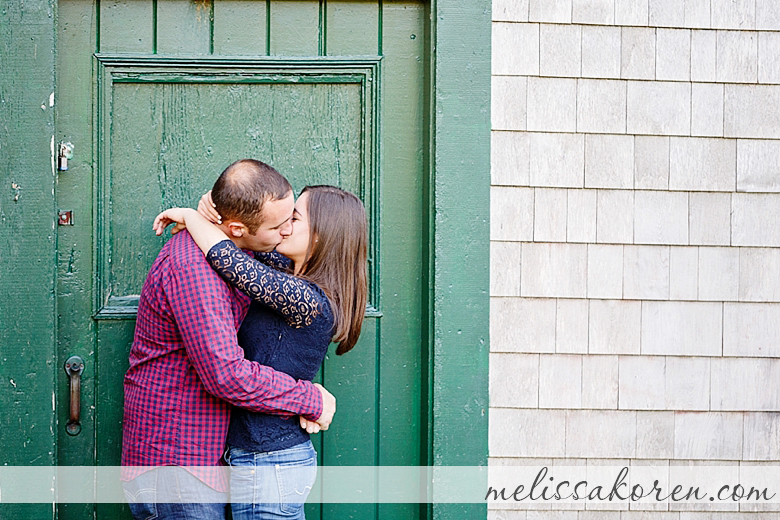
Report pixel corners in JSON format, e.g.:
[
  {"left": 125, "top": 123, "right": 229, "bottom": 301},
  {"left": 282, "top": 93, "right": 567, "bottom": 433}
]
[{"left": 122, "top": 231, "right": 322, "bottom": 491}]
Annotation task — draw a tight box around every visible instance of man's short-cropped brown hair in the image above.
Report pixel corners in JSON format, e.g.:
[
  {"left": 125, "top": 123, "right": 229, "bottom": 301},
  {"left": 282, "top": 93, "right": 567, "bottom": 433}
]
[{"left": 211, "top": 159, "right": 292, "bottom": 235}]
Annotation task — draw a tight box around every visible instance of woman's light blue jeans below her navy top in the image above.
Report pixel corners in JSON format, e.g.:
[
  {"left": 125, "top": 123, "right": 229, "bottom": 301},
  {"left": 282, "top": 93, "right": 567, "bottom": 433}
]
[{"left": 225, "top": 441, "right": 317, "bottom": 520}]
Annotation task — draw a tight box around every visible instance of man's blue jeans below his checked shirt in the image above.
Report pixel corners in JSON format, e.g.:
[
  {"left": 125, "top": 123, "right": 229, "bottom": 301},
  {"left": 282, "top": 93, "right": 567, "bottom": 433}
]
[{"left": 122, "top": 466, "right": 228, "bottom": 520}]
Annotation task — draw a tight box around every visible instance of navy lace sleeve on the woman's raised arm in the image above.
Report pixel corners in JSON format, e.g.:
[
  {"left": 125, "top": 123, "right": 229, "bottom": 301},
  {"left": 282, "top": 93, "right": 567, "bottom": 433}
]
[{"left": 206, "top": 239, "right": 324, "bottom": 328}]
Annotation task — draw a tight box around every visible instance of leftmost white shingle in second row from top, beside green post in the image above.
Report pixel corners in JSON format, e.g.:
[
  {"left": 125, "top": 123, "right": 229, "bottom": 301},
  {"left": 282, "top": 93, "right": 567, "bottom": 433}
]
[{"left": 492, "top": 22, "right": 539, "bottom": 76}]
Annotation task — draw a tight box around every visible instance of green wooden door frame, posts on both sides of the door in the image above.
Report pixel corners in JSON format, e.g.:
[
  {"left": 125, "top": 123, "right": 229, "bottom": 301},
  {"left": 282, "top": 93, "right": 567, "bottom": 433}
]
[{"left": 0, "top": 0, "right": 491, "bottom": 519}]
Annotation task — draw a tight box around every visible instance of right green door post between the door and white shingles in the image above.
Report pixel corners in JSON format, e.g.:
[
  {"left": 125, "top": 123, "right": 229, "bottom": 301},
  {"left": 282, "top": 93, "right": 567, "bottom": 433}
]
[{"left": 428, "top": 0, "right": 491, "bottom": 520}]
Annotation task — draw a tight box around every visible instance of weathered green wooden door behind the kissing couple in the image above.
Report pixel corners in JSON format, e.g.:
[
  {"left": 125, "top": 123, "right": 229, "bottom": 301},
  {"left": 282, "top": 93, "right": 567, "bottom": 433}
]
[{"left": 55, "top": 0, "right": 428, "bottom": 519}]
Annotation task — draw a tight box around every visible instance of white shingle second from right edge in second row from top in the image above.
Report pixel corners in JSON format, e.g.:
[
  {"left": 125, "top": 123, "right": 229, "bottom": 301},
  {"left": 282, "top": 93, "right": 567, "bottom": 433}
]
[{"left": 716, "top": 31, "right": 758, "bottom": 83}]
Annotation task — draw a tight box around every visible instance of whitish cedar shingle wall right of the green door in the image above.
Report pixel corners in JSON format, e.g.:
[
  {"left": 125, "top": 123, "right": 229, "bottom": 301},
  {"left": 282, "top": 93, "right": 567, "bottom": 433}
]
[{"left": 489, "top": 0, "right": 780, "bottom": 520}]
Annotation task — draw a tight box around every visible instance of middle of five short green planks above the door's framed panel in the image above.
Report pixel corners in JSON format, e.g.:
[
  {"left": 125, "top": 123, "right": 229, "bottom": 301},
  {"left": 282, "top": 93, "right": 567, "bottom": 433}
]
[{"left": 214, "top": 0, "right": 268, "bottom": 56}]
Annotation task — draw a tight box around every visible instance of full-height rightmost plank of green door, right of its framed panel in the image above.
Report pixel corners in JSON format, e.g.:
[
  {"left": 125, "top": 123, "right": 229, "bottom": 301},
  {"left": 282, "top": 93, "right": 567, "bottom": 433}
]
[{"left": 377, "top": 2, "right": 427, "bottom": 519}]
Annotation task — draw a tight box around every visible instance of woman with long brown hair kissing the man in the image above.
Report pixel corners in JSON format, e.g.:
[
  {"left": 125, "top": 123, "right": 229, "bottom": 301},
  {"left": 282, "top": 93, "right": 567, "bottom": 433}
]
[{"left": 154, "top": 186, "right": 367, "bottom": 520}]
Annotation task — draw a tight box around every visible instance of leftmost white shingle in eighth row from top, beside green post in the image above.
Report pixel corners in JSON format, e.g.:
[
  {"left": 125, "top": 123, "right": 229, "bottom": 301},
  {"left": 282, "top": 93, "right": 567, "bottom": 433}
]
[{"left": 490, "top": 353, "right": 539, "bottom": 408}]
